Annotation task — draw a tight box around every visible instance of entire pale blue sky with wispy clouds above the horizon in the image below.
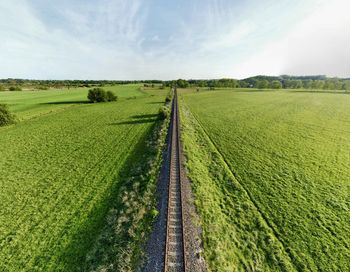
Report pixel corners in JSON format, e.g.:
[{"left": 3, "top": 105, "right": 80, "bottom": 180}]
[{"left": 0, "top": 0, "right": 350, "bottom": 79}]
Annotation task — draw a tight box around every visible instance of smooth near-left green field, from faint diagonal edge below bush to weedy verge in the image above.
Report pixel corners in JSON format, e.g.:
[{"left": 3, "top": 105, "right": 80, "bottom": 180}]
[{"left": 0, "top": 88, "right": 165, "bottom": 271}]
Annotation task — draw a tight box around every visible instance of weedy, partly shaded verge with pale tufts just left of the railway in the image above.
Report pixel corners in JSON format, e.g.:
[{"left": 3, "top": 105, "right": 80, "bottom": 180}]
[{"left": 84, "top": 99, "right": 170, "bottom": 271}]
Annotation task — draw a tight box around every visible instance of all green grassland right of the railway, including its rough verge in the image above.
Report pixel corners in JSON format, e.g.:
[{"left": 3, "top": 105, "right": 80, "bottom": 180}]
[{"left": 180, "top": 90, "right": 350, "bottom": 271}]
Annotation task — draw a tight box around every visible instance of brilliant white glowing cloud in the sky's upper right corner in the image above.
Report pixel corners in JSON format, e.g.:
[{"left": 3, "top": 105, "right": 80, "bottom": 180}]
[{"left": 234, "top": 0, "right": 350, "bottom": 77}]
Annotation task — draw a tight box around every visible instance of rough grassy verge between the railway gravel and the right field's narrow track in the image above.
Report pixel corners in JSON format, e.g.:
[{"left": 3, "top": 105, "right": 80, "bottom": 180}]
[{"left": 180, "top": 102, "right": 295, "bottom": 271}]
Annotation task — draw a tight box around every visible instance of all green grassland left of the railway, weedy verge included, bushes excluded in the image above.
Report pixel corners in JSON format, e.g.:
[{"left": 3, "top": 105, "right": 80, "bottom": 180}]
[{"left": 0, "top": 85, "right": 167, "bottom": 271}]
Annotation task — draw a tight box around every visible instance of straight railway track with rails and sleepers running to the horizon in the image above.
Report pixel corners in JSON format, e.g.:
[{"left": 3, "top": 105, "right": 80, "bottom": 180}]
[{"left": 164, "top": 90, "right": 186, "bottom": 272}]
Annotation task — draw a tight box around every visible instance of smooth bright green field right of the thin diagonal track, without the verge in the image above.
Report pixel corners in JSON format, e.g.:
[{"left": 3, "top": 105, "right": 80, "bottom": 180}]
[{"left": 183, "top": 90, "right": 350, "bottom": 271}]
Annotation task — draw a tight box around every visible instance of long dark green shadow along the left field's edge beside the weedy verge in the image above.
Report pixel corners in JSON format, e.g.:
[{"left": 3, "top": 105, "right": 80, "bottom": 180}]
[{"left": 57, "top": 123, "right": 157, "bottom": 271}]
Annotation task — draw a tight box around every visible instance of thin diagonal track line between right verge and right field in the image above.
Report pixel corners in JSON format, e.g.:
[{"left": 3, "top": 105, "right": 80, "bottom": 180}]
[{"left": 181, "top": 99, "right": 297, "bottom": 271}]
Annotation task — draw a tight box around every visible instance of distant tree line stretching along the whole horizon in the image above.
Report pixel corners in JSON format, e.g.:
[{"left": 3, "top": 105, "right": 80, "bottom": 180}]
[{"left": 0, "top": 75, "right": 350, "bottom": 91}]
